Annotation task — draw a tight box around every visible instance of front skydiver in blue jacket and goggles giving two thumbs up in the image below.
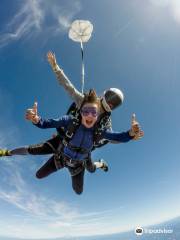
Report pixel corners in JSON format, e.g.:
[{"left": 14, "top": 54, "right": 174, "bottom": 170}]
[{"left": 0, "top": 90, "right": 144, "bottom": 194}]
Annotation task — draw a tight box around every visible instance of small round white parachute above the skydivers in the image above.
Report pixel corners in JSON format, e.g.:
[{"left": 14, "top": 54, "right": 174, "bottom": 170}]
[{"left": 69, "top": 20, "right": 93, "bottom": 43}]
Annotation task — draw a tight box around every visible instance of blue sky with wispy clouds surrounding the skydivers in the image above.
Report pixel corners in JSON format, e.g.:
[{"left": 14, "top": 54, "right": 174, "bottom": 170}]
[{"left": 0, "top": 0, "right": 180, "bottom": 238}]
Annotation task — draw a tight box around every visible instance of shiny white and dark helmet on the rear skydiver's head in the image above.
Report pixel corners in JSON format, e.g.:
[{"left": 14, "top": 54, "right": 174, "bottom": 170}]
[{"left": 101, "top": 88, "right": 124, "bottom": 112}]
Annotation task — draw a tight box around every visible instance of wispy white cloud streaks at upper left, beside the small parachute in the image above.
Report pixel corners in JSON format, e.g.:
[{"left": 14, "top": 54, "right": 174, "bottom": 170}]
[{"left": 0, "top": 0, "right": 81, "bottom": 48}]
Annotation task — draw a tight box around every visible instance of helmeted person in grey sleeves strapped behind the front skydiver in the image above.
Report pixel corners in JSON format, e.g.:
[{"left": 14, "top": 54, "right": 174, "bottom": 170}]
[{"left": 0, "top": 52, "right": 124, "bottom": 165}]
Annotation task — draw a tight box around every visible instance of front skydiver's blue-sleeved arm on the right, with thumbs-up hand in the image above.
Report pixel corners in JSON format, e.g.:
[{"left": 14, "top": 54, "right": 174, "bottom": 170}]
[{"left": 102, "top": 114, "right": 144, "bottom": 143}]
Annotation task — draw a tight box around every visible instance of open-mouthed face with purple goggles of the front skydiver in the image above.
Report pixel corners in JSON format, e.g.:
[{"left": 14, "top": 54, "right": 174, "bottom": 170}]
[{"left": 81, "top": 103, "right": 99, "bottom": 128}]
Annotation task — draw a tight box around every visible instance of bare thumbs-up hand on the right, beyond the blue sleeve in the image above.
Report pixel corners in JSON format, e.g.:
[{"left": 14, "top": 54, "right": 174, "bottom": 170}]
[{"left": 129, "top": 114, "right": 144, "bottom": 140}]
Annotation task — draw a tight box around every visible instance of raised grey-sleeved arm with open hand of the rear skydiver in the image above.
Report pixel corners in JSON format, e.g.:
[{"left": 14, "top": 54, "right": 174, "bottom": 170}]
[{"left": 47, "top": 52, "right": 84, "bottom": 108}]
